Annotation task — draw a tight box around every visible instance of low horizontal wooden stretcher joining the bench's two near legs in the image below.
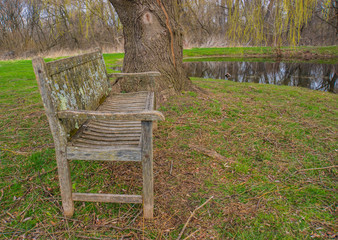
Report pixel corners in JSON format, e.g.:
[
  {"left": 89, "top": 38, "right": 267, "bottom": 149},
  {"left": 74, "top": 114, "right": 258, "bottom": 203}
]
[{"left": 73, "top": 193, "right": 142, "bottom": 203}]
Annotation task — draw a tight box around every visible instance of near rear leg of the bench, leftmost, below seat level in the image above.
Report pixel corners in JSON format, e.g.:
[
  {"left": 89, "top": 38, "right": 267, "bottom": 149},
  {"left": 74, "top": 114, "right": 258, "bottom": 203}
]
[{"left": 55, "top": 150, "right": 74, "bottom": 217}]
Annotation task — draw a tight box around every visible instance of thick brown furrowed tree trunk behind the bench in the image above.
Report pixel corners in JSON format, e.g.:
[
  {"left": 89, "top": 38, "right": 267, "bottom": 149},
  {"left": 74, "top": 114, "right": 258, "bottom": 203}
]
[{"left": 110, "top": 0, "right": 192, "bottom": 102}]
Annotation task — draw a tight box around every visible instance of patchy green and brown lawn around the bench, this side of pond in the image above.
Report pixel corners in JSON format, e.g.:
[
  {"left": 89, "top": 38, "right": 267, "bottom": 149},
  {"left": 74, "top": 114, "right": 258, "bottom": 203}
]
[{"left": 0, "top": 55, "right": 338, "bottom": 239}]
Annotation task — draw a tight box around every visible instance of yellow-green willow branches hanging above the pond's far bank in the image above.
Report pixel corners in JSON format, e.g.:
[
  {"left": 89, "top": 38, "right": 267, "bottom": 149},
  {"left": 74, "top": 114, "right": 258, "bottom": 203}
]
[{"left": 227, "top": 0, "right": 320, "bottom": 45}]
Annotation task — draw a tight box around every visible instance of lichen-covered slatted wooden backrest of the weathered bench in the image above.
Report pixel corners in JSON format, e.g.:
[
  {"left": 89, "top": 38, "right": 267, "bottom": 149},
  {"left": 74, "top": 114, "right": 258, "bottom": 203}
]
[{"left": 33, "top": 51, "right": 109, "bottom": 136}]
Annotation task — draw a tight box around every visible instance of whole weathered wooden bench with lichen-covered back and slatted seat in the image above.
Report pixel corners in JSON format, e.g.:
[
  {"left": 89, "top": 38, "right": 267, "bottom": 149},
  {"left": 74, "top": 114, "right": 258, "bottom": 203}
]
[{"left": 33, "top": 51, "right": 164, "bottom": 218}]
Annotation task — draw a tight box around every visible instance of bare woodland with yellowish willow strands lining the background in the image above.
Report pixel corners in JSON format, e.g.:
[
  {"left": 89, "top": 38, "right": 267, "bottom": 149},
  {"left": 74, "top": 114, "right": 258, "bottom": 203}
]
[{"left": 0, "top": 0, "right": 338, "bottom": 57}]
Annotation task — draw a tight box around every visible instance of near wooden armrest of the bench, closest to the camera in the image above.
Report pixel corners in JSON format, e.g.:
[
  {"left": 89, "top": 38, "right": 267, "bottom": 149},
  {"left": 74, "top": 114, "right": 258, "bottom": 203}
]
[{"left": 56, "top": 110, "right": 165, "bottom": 121}]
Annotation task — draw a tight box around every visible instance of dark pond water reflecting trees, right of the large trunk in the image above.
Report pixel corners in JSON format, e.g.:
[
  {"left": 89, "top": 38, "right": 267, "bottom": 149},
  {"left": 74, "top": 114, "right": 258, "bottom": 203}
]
[{"left": 184, "top": 61, "right": 338, "bottom": 93}]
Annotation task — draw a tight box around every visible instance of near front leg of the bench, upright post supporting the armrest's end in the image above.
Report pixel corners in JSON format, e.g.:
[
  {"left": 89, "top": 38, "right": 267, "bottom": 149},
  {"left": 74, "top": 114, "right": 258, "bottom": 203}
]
[{"left": 141, "top": 121, "right": 154, "bottom": 219}]
